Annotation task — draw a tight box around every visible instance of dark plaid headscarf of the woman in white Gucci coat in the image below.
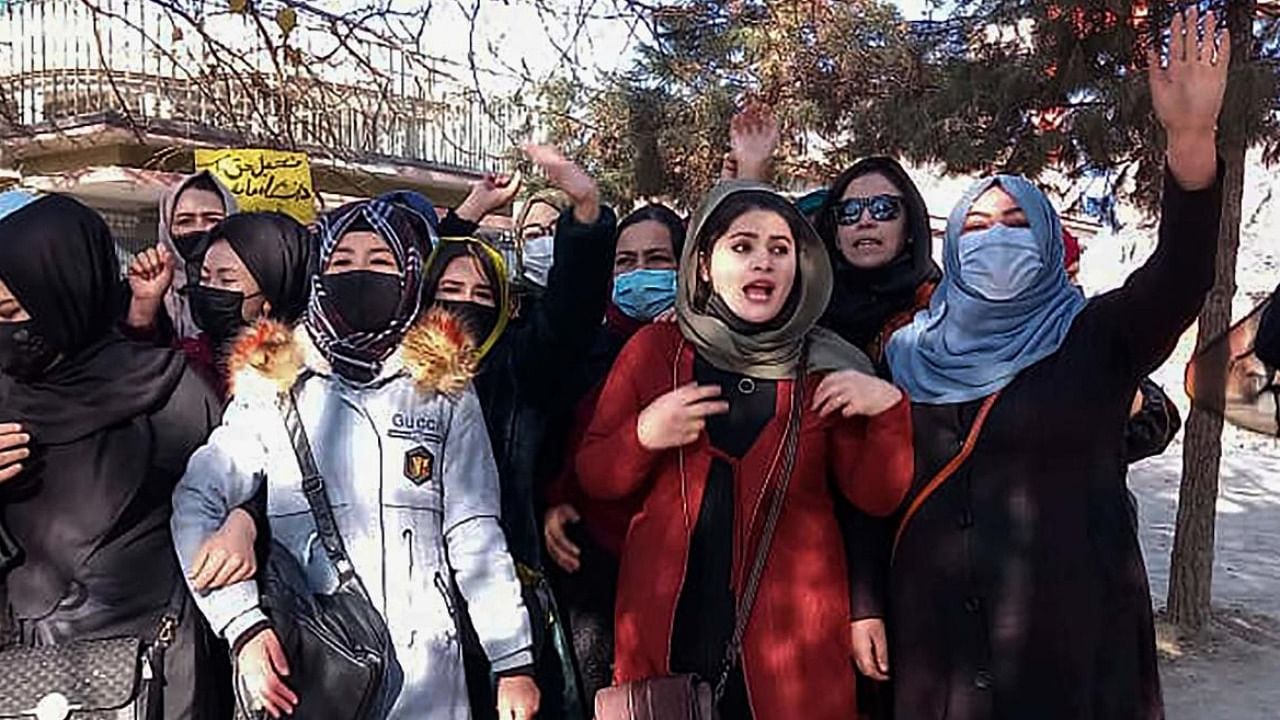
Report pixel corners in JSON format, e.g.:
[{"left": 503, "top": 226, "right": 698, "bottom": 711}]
[{"left": 306, "top": 197, "right": 436, "bottom": 382}]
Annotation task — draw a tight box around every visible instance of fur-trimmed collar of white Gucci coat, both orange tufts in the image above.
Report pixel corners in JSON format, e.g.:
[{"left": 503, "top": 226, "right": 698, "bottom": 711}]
[{"left": 227, "top": 307, "right": 479, "bottom": 398}]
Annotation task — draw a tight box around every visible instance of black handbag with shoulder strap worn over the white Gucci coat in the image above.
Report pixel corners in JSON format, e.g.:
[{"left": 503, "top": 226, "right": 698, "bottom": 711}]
[{"left": 237, "top": 393, "right": 399, "bottom": 720}]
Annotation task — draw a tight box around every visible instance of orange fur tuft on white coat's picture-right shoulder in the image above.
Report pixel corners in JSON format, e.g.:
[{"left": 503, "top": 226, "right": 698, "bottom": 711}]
[{"left": 401, "top": 307, "right": 477, "bottom": 395}]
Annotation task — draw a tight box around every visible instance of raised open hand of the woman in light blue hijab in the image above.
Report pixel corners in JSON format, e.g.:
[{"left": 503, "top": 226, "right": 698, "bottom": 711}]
[{"left": 1148, "top": 5, "right": 1231, "bottom": 190}]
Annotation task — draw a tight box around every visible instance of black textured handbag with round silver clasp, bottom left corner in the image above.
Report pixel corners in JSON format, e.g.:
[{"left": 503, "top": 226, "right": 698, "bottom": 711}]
[{"left": 0, "top": 580, "right": 187, "bottom": 720}]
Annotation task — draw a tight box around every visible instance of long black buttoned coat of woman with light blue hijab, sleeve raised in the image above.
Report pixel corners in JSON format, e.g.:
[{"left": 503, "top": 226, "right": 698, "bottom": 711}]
[{"left": 888, "top": 169, "right": 1221, "bottom": 720}]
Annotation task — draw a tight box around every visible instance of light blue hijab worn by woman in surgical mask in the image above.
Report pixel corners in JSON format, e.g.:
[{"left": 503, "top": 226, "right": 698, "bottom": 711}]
[{"left": 886, "top": 176, "right": 1084, "bottom": 405}]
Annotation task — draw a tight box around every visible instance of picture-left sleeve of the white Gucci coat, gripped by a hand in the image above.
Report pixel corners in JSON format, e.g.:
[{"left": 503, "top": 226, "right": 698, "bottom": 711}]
[{"left": 169, "top": 402, "right": 270, "bottom": 643}]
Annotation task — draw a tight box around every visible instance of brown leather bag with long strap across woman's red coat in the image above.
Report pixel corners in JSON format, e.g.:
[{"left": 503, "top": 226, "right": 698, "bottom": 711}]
[{"left": 595, "top": 354, "right": 808, "bottom": 720}]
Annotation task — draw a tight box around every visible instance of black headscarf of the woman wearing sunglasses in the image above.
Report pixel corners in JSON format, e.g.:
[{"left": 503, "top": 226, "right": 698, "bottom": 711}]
[{"left": 814, "top": 156, "right": 942, "bottom": 350}]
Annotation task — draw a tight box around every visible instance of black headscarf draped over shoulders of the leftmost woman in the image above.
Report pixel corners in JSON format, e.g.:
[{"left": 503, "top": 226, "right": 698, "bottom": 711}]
[{"left": 0, "top": 195, "right": 184, "bottom": 445}]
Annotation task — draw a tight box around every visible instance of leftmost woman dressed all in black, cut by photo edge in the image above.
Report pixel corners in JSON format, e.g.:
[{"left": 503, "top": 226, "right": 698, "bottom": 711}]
[{"left": 0, "top": 195, "right": 220, "bottom": 719}]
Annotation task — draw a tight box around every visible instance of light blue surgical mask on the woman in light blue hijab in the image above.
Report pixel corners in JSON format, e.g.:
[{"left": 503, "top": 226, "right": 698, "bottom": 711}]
[{"left": 957, "top": 225, "right": 1044, "bottom": 302}]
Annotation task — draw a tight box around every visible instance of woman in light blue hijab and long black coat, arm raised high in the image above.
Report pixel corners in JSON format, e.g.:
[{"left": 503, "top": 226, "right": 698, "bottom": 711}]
[{"left": 887, "top": 8, "right": 1229, "bottom": 720}]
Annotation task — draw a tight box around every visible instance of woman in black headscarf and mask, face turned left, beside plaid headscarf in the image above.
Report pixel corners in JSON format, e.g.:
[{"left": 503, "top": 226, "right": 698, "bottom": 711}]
[{"left": 182, "top": 213, "right": 312, "bottom": 397}]
